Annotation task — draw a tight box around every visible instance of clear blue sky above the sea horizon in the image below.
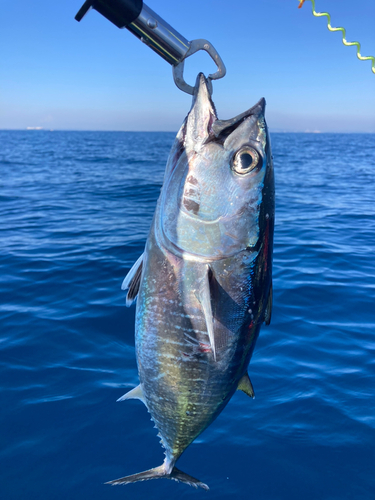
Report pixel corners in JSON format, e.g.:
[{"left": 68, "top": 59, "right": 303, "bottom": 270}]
[{"left": 0, "top": 0, "right": 375, "bottom": 132}]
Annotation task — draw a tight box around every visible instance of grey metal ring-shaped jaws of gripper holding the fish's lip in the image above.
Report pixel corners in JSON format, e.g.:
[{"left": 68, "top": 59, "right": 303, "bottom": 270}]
[{"left": 173, "top": 38, "right": 227, "bottom": 95}]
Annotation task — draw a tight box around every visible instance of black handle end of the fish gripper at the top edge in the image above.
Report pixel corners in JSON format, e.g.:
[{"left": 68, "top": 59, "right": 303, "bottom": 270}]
[{"left": 75, "top": 0, "right": 143, "bottom": 28}]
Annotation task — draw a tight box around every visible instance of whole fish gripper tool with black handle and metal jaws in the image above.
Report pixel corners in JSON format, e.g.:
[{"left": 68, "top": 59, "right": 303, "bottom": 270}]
[{"left": 75, "top": 0, "right": 226, "bottom": 95}]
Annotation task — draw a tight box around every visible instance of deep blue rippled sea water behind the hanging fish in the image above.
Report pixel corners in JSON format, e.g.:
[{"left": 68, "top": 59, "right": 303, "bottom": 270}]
[{"left": 0, "top": 131, "right": 375, "bottom": 500}]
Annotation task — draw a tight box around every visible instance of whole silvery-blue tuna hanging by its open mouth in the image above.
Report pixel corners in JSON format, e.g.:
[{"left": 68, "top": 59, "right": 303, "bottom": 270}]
[{"left": 108, "top": 73, "right": 275, "bottom": 489}]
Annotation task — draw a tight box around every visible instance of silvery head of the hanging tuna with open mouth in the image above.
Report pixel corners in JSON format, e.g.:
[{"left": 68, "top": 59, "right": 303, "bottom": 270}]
[{"left": 158, "top": 74, "right": 273, "bottom": 260}]
